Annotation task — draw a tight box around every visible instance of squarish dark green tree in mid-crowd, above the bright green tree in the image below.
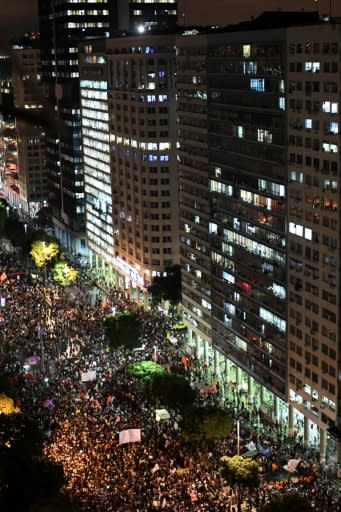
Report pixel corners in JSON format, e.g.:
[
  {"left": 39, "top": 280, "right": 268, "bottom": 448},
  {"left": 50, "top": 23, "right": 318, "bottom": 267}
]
[{"left": 104, "top": 311, "right": 140, "bottom": 350}]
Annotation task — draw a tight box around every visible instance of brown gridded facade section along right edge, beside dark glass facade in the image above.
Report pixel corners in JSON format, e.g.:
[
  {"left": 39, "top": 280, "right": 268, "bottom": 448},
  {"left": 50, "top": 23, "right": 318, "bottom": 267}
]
[{"left": 286, "top": 22, "right": 341, "bottom": 451}]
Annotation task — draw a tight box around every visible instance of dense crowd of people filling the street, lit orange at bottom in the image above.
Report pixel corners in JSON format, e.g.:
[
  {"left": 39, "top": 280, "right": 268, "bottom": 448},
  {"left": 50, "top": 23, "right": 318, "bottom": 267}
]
[{"left": 0, "top": 250, "right": 341, "bottom": 512}]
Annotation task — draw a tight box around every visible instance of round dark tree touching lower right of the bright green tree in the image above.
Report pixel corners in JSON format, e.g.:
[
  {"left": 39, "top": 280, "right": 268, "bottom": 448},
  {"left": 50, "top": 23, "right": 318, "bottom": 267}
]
[{"left": 151, "top": 372, "right": 195, "bottom": 409}]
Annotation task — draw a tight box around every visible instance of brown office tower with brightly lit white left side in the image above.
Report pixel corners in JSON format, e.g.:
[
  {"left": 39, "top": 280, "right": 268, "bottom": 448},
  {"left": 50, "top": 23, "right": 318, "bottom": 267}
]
[{"left": 80, "top": 35, "right": 179, "bottom": 301}]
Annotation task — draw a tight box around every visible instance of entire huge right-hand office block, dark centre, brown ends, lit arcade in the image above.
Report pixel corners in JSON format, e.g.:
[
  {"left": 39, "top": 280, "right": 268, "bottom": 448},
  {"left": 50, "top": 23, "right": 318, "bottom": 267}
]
[{"left": 177, "top": 13, "right": 341, "bottom": 457}]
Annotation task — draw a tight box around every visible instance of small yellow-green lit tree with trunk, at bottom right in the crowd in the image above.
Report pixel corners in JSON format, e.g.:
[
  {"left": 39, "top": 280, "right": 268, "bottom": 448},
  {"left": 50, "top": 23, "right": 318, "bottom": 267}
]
[{"left": 219, "top": 455, "right": 259, "bottom": 512}]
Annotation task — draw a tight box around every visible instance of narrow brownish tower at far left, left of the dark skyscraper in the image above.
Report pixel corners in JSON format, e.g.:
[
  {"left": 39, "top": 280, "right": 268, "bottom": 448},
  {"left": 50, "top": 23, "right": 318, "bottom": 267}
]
[{"left": 11, "top": 36, "right": 47, "bottom": 217}]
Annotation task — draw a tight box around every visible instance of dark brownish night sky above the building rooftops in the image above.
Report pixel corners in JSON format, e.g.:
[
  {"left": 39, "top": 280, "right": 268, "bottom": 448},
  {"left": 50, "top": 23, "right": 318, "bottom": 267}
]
[{"left": 0, "top": 0, "right": 341, "bottom": 49}]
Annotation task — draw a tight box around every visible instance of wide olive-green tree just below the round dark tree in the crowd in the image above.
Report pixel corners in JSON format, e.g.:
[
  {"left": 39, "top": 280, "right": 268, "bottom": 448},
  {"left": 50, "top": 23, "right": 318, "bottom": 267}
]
[{"left": 181, "top": 407, "right": 233, "bottom": 441}]
